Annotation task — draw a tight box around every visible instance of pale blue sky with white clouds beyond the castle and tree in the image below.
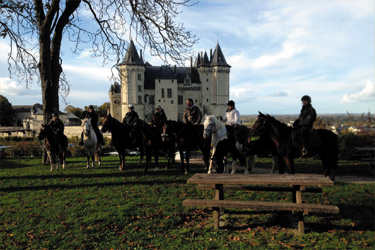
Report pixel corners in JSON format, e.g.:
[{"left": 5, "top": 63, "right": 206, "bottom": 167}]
[{"left": 0, "top": 0, "right": 375, "bottom": 115}]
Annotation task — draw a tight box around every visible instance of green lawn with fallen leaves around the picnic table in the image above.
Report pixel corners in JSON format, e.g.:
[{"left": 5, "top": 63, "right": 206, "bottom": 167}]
[{"left": 0, "top": 156, "right": 375, "bottom": 249}]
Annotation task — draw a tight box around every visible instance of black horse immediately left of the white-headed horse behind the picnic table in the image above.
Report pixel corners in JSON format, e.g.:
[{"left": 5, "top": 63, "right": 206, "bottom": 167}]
[{"left": 162, "top": 120, "right": 211, "bottom": 174}]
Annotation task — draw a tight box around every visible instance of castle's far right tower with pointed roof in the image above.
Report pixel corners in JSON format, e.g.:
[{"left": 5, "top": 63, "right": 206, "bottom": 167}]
[{"left": 210, "top": 43, "right": 231, "bottom": 115}]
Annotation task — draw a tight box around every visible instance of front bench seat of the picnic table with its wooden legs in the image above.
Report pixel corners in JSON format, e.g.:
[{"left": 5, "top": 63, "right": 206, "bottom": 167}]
[{"left": 182, "top": 199, "right": 340, "bottom": 234}]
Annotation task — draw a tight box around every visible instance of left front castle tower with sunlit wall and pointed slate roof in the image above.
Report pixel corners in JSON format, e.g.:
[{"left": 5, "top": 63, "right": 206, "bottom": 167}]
[{"left": 119, "top": 40, "right": 145, "bottom": 119}]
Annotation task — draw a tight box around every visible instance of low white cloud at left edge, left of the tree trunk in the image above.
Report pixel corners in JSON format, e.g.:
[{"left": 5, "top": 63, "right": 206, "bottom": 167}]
[{"left": 0, "top": 77, "right": 41, "bottom": 96}]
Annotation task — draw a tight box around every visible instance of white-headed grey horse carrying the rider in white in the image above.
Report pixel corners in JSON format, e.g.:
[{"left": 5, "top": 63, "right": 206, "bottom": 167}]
[{"left": 203, "top": 115, "right": 249, "bottom": 174}]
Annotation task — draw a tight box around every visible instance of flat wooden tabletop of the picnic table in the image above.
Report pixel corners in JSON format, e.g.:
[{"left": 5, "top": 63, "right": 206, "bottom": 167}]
[{"left": 187, "top": 174, "right": 334, "bottom": 186}]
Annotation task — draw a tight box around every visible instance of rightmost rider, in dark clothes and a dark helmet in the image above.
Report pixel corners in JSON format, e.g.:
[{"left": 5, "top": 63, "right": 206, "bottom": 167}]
[{"left": 293, "top": 95, "right": 316, "bottom": 156}]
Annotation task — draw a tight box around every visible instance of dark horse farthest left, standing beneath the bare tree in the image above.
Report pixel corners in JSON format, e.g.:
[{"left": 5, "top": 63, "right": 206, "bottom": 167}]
[{"left": 38, "top": 124, "right": 68, "bottom": 171}]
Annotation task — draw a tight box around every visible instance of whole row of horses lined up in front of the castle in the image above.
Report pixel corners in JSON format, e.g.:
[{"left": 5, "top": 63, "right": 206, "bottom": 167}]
[{"left": 39, "top": 112, "right": 338, "bottom": 180}]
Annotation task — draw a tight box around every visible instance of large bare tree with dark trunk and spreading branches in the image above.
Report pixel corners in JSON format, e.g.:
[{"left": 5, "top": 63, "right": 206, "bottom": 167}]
[{"left": 0, "top": 0, "right": 197, "bottom": 121}]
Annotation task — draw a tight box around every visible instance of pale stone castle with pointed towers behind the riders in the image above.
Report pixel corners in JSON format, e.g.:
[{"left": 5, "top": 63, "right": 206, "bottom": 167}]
[{"left": 109, "top": 41, "right": 231, "bottom": 121}]
